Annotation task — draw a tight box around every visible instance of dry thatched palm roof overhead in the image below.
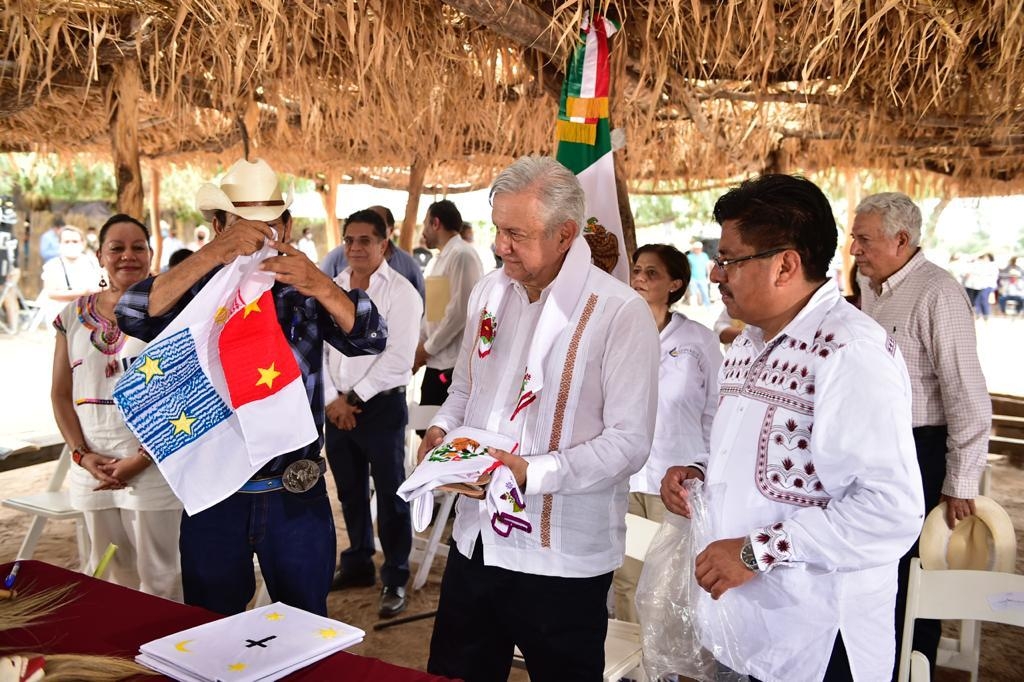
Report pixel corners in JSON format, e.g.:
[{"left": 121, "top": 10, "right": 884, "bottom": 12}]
[{"left": 0, "top": 0, "right": 1024, "bottom": 194}]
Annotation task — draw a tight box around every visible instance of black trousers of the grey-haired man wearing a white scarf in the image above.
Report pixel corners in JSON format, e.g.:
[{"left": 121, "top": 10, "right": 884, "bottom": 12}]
[{"left": 427, "top": 539, "right": 611, "bottom": 682}]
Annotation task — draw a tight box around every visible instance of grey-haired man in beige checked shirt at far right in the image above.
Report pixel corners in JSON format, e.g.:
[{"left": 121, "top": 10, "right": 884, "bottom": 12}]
[{"left": 850, "top": 191, "right": 992, "bottom": 667}]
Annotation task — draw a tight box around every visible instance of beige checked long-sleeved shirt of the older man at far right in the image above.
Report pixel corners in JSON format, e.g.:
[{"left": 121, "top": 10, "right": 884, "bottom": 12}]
[{"left": 861, "top": 250, "right": 992, "bottom": 499}]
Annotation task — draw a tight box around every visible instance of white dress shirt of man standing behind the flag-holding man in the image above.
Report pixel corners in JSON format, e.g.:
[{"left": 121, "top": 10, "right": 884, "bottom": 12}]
[{"left": 324, "top": 261, "right": 423, "bottom": 402}]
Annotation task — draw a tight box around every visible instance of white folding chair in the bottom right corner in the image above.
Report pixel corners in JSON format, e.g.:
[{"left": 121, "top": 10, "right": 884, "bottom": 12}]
[{"left": 896, "top": 558, "right": 1024, "bottom": 682}]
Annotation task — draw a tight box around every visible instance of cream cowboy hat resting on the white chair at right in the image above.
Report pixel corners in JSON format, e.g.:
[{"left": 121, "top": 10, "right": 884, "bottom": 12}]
[{"left": 921, "top": 495, "right": 1017, "bottom": 573}]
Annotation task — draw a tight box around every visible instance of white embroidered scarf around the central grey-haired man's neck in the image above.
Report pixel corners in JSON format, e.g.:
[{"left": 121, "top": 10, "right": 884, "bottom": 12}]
[{"left": 476, "top": 238, "right": 591, "bottom": 419}]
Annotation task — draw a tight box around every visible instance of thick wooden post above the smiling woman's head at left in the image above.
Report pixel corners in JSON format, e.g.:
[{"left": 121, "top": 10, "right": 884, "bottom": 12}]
[{"left": 110, "top": 59, "right": 145, "bottom": 219}]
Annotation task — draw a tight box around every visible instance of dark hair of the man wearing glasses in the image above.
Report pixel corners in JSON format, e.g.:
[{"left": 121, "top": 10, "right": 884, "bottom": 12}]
[{"left": 715, "top": 174, "right": 839, "bottom": 282}]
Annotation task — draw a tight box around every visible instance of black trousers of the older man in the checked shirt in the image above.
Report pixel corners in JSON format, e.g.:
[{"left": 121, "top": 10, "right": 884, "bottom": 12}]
[{"left": 893, "top": 425, "right": 947, "bottom": 680}]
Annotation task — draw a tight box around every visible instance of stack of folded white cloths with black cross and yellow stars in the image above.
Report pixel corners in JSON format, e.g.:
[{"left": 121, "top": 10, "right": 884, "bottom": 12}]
[{"left": 135, "top": 602, "right": 366, "bottom": 682}]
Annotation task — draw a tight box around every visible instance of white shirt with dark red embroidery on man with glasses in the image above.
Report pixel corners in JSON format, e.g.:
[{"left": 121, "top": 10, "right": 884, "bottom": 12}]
[{"left": 698, "top": 282, "right": 924, "bottom": 682}]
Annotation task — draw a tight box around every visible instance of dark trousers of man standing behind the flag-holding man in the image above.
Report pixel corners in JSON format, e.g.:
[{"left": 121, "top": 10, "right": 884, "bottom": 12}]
[{"left": 325, "top": 393, "right": 413, "bottom": 587}]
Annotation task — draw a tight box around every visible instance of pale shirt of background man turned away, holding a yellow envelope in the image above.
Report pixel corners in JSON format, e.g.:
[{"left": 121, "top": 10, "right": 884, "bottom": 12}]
[{"left": 420, "top": 235, "right": 483, "bottom": 370}]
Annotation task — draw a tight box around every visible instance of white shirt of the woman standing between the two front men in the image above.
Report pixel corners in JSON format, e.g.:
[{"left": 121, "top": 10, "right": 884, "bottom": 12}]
[{"left": 630, "top": 312, "right": 722, "bottom": 495}]
